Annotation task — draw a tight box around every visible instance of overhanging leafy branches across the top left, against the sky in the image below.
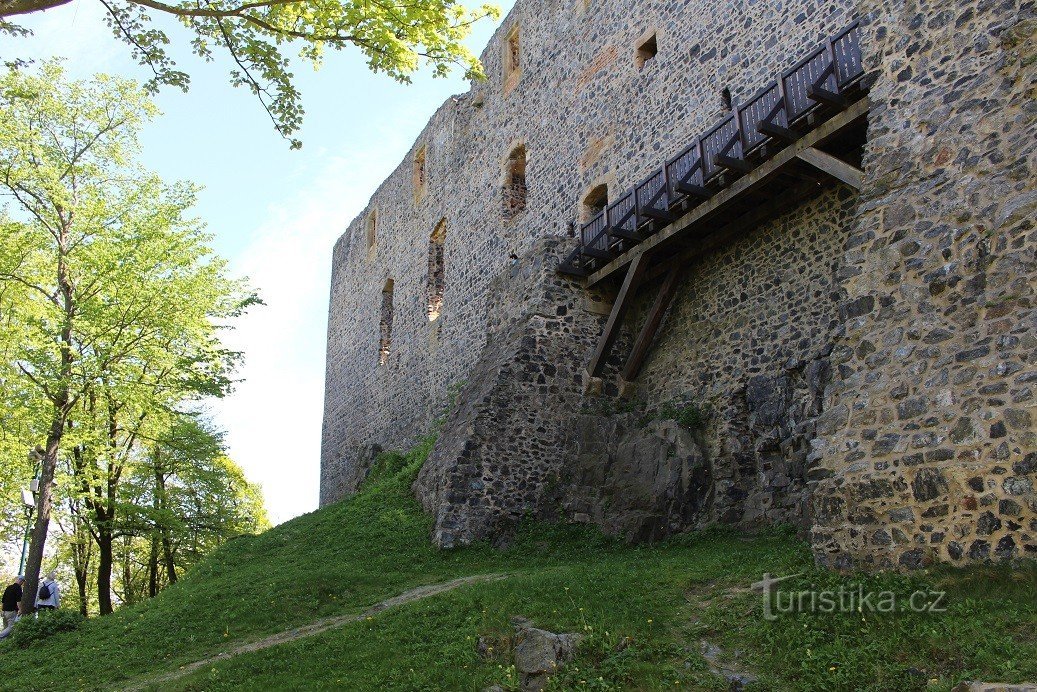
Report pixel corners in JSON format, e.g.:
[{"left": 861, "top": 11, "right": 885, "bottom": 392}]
[{"left": 0, "top": 0, "right": 499, "bottom": 148}]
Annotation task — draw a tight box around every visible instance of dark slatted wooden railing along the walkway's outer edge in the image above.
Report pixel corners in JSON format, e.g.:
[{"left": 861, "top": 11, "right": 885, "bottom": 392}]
[{"left": 559, "top": 22, "right": 864, "bottom": 276}]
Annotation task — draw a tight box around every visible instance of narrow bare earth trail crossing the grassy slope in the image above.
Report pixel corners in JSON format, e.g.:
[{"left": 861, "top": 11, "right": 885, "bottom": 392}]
[{"left": 122, "top": 574, "right": 507, "bottom": 691}]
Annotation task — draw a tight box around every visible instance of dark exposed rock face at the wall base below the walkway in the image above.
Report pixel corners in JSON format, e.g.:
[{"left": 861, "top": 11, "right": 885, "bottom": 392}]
[{"left": 560, "top": 358, "right": 830, "bottom": 541}]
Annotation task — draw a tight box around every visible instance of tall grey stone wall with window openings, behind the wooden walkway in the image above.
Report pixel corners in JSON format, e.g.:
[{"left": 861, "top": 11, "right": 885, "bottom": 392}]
[{"left": 320, "top": 0, "right": 854, "bottom": 503}]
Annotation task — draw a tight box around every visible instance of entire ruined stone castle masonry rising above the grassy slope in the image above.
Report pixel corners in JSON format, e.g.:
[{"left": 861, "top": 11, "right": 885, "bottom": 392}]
[{"left": 321, "top": 0, "right": 1037, "bottom": 568}]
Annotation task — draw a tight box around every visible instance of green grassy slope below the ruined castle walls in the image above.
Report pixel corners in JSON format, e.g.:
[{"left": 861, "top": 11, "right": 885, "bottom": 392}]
[{"left": 0, "top": 444, "right": 1037, "bottom": 690}]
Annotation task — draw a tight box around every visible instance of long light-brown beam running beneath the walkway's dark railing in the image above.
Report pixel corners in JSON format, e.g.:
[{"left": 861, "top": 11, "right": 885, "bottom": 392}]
[{"left": 587, "top": 96, "right": 870, "bottom": 286}]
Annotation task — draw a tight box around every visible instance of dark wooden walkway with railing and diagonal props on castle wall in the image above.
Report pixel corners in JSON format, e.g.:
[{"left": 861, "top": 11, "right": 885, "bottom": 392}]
[{"left": 558, "top": 22, "right": 870, "bottom": 382}]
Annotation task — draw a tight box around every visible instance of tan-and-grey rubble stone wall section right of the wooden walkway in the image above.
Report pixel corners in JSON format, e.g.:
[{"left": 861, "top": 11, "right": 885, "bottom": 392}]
[{"left": 812, "top": 0, "right": 1037, "bottom": 568}]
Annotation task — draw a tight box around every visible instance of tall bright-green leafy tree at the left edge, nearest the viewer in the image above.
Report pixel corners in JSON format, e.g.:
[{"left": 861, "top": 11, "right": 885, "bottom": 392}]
[{"left": 0, "top": 63, "right": 258, "bottom": 612}]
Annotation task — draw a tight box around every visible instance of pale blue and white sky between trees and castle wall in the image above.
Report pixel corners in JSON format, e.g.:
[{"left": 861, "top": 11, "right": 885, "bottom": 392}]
[{"left": 0, "top": 0, "right": 513, "bottom": 523}]
